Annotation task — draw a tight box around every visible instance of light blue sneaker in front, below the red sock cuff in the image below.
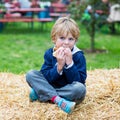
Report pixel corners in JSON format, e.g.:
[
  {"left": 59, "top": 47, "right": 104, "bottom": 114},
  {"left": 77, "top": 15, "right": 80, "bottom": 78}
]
[{"left": 55, "top": 98, "right": 76, "bottom": 113}]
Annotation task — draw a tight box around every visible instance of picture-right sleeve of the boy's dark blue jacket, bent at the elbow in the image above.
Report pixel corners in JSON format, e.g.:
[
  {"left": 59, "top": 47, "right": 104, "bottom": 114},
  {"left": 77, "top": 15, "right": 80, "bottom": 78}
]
[{"left": 64, "top": 52, "right": 87, "bottom": 84}]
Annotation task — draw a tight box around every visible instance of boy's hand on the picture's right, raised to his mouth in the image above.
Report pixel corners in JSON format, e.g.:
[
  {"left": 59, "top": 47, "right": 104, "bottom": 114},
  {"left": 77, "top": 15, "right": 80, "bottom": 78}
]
[{"left": 64, "top": 48, "right": 73, "bottom": 65}]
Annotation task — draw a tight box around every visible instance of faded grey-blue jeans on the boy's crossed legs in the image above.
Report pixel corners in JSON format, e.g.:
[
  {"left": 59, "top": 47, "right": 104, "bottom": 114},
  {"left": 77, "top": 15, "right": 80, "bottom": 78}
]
[{"left": 26, "top": 70, "right": 86, "bottom": 103}]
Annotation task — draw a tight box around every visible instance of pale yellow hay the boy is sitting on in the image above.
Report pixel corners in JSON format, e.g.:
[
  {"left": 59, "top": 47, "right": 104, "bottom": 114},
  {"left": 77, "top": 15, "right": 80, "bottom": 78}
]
[{"left": 0, "top": 69, "right": 120, "bottom": 120}]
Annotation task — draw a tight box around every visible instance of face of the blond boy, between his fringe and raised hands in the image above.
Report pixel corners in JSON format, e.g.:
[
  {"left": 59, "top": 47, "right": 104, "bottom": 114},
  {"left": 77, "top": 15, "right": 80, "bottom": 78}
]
[{"left": 55, "top": 33, "right": 76, "bottom": 49}]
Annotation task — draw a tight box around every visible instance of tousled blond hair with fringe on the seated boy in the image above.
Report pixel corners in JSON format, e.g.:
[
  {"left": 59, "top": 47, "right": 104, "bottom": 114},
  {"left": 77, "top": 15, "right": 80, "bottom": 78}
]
[{"left": 51, "top": 17, "right": 80, "bottom": 42}]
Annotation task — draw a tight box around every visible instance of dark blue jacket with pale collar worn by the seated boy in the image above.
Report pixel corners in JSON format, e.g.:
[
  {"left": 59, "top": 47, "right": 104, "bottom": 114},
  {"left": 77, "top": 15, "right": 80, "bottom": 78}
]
[{"left": 41, "top": 46, "right": 87, "bottom": 87}]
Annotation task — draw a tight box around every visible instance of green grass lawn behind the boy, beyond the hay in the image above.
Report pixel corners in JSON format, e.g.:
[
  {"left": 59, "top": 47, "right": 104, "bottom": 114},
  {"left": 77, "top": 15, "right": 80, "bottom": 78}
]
[{"left": 0, "top": 23, "right": 120, "bottom": 74}]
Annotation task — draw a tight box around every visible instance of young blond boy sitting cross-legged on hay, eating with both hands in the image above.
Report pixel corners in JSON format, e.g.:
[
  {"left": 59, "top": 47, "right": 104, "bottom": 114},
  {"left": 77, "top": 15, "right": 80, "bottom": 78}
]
[{"left": 26, "top": 17, "right": 87, "bottom": 113}]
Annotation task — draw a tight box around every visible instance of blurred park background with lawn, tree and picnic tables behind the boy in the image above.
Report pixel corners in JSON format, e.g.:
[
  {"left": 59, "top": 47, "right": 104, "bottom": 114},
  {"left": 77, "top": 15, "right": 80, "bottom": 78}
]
[{"left": 0, "top": 0, "right": 120, "bottom": 74}]
